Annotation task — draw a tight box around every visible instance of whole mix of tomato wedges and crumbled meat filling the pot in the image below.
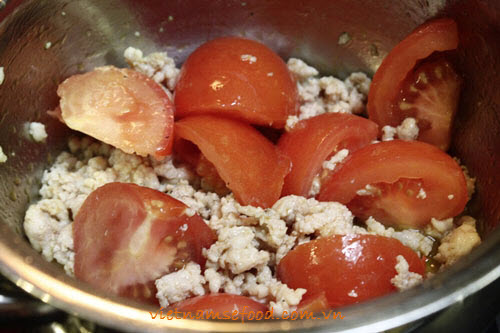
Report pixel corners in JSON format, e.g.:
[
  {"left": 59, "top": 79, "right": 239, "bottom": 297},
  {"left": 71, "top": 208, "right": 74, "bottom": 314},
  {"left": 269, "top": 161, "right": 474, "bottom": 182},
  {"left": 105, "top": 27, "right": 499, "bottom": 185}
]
[{"left": 24, "top": 20, "right": 480, "bottom": 314}]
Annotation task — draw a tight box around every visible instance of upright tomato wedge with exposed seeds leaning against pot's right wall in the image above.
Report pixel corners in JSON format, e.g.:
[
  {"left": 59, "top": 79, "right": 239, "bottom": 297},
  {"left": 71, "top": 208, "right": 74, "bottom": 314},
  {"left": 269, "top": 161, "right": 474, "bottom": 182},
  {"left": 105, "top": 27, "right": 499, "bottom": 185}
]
[{"left": 367, "top": 18, "right": 461, "bottom": 150}]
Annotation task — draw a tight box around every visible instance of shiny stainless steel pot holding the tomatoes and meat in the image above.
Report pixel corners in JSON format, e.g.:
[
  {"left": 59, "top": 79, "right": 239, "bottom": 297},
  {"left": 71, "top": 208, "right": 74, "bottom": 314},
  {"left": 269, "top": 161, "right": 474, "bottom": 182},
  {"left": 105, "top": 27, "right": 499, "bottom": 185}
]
[{"left": 0, "top": 0, "right": 500, "bottom": 332}]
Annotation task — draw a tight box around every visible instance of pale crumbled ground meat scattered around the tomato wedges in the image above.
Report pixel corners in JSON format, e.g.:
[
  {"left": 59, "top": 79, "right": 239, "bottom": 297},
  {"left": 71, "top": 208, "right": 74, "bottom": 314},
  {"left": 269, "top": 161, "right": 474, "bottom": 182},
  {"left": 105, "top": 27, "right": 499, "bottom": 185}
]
[{"left": 22, "top": 47, "right": 480, "bottom": 313}]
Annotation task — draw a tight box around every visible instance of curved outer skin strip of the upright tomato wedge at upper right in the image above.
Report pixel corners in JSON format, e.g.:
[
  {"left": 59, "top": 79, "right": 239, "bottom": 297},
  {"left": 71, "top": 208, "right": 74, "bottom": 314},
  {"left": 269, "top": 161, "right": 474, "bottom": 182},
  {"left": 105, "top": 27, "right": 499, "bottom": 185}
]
[{"left": 366, "top": 18, "right": 458, "bottom": 128}]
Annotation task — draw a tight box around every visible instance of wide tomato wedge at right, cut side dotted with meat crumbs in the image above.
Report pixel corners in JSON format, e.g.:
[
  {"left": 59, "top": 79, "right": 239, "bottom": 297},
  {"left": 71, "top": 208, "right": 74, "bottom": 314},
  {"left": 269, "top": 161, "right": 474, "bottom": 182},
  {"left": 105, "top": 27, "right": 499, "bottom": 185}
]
[{"left": 318, "top": 140, "right": 467, "bottom": 228}]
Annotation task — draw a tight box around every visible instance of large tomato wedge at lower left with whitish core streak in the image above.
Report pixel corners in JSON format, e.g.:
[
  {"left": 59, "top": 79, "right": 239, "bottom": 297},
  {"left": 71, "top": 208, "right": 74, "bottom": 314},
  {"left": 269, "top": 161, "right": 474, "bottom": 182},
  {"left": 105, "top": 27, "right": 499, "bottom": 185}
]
[{"left": 73, "top": 183, "right": 216, "bottom": 304}]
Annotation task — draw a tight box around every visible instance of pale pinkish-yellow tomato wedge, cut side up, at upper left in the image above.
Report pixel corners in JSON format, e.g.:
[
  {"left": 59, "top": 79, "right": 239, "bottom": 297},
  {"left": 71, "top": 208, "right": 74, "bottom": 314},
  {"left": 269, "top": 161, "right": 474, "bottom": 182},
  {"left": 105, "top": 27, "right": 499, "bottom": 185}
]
[{"left": 55, "top": 66, "right": 174, "bottom": 159}]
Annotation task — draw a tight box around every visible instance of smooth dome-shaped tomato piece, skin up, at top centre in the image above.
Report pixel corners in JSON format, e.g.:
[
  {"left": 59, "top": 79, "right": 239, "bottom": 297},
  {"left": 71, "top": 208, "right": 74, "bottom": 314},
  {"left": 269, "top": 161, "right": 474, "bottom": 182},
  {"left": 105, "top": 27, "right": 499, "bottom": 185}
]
[{"left": 175, "top": 37, "right": 299, "bottom": 128}]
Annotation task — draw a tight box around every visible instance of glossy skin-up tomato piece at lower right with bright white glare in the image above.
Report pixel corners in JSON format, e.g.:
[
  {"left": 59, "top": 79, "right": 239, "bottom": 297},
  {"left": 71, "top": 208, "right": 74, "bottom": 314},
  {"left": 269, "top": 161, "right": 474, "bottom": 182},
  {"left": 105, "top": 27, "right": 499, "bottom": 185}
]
[{"left": 278, "top": 235, "right": 425, "bottom": 307}]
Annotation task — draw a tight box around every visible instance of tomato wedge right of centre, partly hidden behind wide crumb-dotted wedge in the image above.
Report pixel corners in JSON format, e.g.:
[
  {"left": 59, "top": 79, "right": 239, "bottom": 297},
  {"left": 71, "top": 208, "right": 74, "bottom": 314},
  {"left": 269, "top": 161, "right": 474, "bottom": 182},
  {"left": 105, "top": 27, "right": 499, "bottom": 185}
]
[{"left": 278, "top": 113, "right": 378, "bottom": 197}]
